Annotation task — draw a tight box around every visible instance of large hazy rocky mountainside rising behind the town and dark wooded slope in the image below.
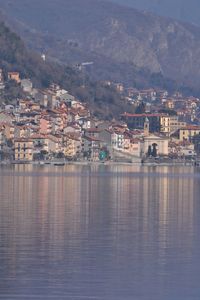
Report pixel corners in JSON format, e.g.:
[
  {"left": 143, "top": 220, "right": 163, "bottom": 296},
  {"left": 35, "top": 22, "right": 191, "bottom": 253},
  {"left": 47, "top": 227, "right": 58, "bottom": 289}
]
[{"left": 0, "top": 0, "right": 200, "bottom": 87}]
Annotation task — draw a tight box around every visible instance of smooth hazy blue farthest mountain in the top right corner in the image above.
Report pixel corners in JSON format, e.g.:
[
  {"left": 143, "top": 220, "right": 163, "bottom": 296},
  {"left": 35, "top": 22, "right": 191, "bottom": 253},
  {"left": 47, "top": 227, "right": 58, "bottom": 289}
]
[{"left": 110, "top": 0, "right": 200, "bottom": 26}]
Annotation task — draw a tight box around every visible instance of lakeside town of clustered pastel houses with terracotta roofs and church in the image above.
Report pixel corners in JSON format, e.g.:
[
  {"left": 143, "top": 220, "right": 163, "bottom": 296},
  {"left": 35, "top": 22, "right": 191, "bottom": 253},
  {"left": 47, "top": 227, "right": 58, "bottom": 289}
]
[{"left": 0, "top": 70, "right": 200, "bottom": 164}]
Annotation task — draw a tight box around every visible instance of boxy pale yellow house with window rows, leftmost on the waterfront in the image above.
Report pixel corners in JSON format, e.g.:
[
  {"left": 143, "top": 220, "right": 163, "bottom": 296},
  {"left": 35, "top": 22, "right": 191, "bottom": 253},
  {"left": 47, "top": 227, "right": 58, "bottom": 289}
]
[{"left": 14, "top": 138, "right": 33, "bottom": 161}]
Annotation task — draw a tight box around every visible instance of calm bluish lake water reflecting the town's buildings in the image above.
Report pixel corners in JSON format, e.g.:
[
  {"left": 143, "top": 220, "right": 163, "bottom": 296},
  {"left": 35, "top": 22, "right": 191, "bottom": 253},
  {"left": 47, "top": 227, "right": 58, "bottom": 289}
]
[{"left": 0, "top": 166, "right": 200, "bottom": 300}]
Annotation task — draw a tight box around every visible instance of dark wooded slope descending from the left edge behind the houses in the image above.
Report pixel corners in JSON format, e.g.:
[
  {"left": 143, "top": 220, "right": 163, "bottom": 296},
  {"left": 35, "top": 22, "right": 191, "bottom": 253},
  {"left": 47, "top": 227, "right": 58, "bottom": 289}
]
[{"left": 0, "top": 18, "right": 136, "bottom": 119}]
